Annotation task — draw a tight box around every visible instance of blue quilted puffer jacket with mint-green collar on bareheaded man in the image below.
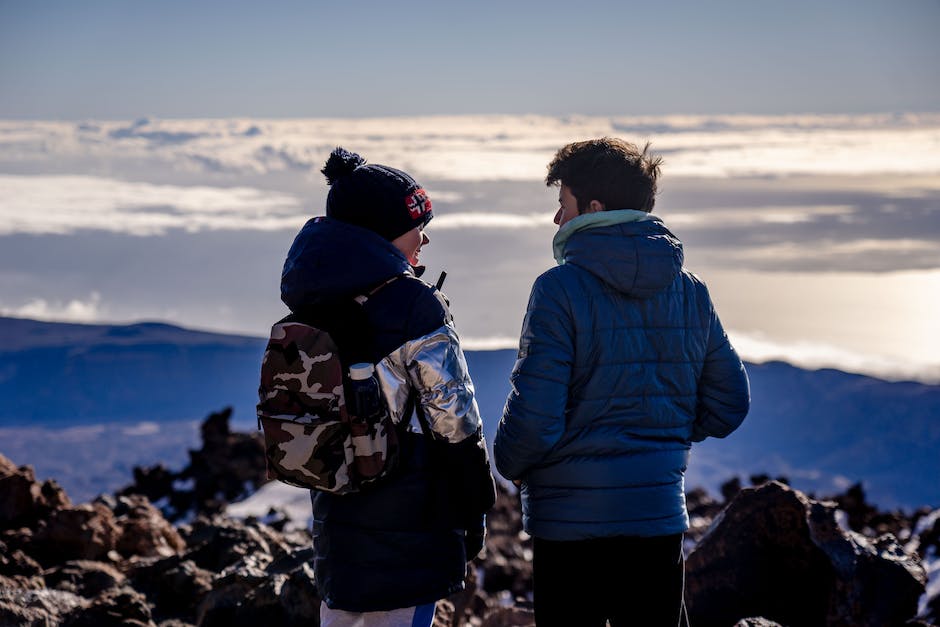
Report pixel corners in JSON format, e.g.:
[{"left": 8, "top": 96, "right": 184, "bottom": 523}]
[{"left": 493, "top": 210, "right": 750, "bottom": 540}]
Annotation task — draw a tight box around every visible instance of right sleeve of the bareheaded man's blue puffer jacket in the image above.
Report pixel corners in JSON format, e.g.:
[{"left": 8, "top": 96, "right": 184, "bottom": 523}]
[{"left": 692, "top": 308, "right": 751, "bottom": 442}]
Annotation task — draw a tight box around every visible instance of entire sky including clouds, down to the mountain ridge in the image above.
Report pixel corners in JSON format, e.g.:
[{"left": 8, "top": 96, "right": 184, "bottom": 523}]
[{"left": 0, "top": 0, "right": 940, "bottom": 382}]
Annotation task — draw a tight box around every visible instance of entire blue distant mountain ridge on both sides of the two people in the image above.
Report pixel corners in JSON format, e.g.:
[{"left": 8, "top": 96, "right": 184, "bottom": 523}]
[{"left": 0, "top": 318, "right": 940, "bottom": 508}]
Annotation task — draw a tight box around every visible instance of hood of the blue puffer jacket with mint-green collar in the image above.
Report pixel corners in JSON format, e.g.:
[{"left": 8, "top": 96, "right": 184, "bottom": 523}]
[{"left": 554, "top": 209, "right": 683, "bottom": 298}]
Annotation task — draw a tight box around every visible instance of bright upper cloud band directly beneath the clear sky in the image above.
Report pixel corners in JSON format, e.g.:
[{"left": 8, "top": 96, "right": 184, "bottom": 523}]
[{"left": 0, "top": 114, "right": 940, "bottom": 181}]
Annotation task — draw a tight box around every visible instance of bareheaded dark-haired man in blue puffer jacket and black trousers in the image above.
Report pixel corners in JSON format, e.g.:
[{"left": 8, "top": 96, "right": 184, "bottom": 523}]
[{"left": 493, "top": 138, "right": 750, "bottom": 627}]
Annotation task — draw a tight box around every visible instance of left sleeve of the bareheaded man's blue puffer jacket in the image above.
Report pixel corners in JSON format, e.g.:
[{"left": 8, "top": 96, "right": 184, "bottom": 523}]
[{"left": 493, "top": 271, "right": 574, "bottom": 480}]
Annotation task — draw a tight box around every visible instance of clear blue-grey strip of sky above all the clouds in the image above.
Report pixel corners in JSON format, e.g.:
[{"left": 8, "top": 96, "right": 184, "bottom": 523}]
[{"left": 0, "top": 0, "right": 940, "bottom": 120}]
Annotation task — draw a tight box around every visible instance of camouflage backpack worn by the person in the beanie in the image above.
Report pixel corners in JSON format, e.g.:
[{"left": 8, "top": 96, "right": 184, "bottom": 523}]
[{"left": 257, "top": 277, "right": 398, "bottom": 494}]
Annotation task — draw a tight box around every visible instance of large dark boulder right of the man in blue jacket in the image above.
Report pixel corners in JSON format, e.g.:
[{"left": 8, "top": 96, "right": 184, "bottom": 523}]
[{"left": 686, "top": 482, "right": 925, "bottom": 627}]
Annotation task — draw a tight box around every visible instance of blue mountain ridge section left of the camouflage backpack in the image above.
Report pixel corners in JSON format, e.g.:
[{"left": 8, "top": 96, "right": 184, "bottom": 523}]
[{"left": 0, "top": 318, "right": 264, "bottom": 426}]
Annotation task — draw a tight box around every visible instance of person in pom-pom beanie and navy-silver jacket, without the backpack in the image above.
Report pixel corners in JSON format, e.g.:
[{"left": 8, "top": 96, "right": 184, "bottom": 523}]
[{"left": 281, "top": 148, "right": 496, "bottom": 627}]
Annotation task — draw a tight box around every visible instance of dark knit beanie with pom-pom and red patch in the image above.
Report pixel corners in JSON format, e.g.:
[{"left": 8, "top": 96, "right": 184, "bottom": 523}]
[{"left": 320, "top": 147, "right": 434, "bottom": 241}]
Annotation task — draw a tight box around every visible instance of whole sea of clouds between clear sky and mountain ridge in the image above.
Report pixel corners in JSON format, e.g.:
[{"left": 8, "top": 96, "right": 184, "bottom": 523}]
[{"left": 0, "top": 113, "right": 940, "bottom": 381}]
